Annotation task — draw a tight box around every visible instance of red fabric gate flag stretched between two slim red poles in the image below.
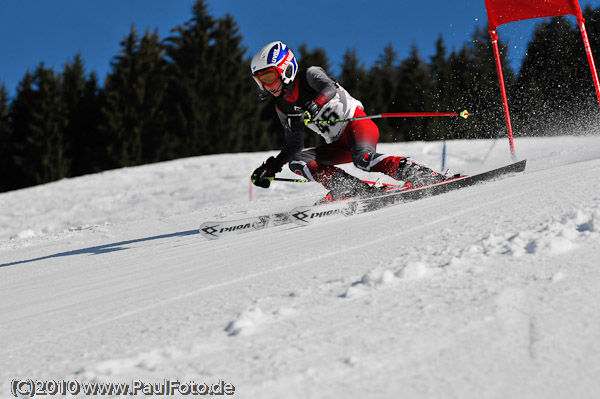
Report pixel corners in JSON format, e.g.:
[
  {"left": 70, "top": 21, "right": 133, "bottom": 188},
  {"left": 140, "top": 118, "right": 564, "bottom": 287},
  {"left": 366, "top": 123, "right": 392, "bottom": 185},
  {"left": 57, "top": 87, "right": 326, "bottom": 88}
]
[{"left": 485, "top": 0, "right": 583, "bottom": 30}]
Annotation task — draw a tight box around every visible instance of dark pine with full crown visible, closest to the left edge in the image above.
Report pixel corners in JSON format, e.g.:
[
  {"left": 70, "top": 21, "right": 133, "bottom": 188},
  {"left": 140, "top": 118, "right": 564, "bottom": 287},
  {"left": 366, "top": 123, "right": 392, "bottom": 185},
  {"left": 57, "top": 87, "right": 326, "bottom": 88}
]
[{"left": 10, "top": 63, "right": 70, "bottom": 188}]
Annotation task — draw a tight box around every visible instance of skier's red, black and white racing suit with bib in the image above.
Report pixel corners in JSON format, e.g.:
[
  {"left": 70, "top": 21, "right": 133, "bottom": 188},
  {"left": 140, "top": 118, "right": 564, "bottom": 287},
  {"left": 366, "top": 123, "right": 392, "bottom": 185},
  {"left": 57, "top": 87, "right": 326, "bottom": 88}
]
[{"left": 276, "top": 66, "right": 404, "bottom": 189}]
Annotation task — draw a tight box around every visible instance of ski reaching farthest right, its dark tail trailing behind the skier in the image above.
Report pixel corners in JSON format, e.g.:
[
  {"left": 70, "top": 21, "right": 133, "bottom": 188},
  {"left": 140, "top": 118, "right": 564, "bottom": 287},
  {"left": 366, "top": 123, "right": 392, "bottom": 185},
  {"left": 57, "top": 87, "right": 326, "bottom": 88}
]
[{"left": 291, "top": 160, "right": 526, "bottom": 226}]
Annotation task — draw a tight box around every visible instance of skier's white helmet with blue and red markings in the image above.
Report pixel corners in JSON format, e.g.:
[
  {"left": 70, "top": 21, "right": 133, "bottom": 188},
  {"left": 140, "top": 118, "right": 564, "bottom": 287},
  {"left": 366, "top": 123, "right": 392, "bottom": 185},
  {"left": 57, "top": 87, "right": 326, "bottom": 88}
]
[{"left": 250, "top": 41, "right": 298, "bottom": 90}]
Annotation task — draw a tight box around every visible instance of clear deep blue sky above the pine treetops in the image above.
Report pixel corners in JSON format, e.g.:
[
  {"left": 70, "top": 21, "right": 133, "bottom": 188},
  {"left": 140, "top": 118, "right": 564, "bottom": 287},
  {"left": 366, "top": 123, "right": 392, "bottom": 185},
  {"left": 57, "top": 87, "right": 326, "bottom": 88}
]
[{"left": 0, "top": 0, "right": 600, "bottom": 96}]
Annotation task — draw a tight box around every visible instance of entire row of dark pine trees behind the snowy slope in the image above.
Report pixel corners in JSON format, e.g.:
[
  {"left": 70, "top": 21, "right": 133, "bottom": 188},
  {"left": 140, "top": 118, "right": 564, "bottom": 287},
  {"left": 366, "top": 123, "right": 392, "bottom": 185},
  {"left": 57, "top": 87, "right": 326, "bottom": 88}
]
[{"left": 0, "top": 0, "right": 600, "bottom": 191}]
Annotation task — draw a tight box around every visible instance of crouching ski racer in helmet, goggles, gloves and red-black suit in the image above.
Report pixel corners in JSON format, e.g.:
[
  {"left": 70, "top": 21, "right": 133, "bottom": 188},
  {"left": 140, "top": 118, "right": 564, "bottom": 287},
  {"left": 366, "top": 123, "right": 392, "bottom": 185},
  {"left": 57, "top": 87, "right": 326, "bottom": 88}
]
[{"left": 251, "top": 41, "right": 445, "bottom": 199}]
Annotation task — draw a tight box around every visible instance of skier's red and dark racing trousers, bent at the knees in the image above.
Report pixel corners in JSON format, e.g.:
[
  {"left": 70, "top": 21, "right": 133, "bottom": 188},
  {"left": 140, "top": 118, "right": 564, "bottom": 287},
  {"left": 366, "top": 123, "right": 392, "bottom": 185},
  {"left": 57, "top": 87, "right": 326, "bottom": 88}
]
[{"left": 289, "top": 108, "right": 404, "bottom": 189}]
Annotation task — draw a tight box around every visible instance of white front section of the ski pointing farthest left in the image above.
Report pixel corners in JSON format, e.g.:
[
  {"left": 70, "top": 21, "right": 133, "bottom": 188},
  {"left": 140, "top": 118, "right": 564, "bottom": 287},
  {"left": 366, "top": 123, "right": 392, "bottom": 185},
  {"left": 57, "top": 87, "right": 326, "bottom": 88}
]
[{"left": 198, "top": 212, "right": 291, "bottom": 240}]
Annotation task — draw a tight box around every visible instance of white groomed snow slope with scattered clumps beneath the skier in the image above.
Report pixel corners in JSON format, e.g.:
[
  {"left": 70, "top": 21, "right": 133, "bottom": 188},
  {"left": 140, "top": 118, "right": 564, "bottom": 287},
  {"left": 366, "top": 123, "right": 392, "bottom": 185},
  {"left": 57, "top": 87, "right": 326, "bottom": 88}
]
[{"left": 0, "top": 135, "right": 600, "bottom": 399}]
